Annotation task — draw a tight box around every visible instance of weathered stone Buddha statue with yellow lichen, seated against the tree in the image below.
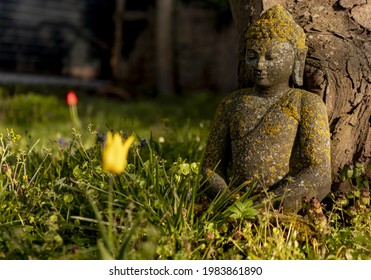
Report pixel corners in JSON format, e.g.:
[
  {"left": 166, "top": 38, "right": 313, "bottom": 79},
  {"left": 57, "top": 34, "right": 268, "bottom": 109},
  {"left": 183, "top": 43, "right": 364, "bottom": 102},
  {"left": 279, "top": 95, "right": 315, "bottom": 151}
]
[{"left": 202, "top": 5, "right": 331, "bottom": 212}]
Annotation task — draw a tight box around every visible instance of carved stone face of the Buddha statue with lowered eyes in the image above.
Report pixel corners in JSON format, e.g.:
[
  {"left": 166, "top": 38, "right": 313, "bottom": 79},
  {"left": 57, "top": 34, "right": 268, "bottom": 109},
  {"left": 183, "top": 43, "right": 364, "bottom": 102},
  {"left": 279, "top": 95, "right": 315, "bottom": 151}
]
[{"left": 246, "top": 40, "right": 295, "bottom": 88}]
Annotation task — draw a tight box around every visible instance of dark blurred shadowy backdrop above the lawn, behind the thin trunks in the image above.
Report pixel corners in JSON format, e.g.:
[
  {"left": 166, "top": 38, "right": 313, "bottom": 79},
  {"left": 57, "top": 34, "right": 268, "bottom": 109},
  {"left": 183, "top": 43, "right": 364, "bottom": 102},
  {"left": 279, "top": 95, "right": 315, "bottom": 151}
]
[{"left": 0, "top": 0, "right": 238, "bottom": 93}]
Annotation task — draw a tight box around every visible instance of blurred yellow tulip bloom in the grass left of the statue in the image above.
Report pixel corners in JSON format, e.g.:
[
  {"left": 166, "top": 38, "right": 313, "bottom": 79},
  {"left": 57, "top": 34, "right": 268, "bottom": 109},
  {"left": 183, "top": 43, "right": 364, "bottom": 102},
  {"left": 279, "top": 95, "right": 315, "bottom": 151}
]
[{"left": 102, "top": 132, "right": 135, "bottom": 174}]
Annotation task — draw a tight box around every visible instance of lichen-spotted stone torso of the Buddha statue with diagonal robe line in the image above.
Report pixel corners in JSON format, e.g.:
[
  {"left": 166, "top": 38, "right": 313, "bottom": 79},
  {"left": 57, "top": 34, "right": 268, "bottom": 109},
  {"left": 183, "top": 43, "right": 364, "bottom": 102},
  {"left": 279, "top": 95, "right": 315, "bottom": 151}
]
[{"left": 228, "top": 90, "right": 301, "bottom": 187}]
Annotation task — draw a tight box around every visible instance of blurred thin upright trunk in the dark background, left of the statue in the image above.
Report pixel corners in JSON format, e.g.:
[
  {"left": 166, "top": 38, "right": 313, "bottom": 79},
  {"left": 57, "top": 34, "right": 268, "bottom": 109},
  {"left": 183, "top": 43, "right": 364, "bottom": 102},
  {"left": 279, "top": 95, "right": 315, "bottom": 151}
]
[{"left": 155, "top": 0, "right": 175, "bottom": 95}]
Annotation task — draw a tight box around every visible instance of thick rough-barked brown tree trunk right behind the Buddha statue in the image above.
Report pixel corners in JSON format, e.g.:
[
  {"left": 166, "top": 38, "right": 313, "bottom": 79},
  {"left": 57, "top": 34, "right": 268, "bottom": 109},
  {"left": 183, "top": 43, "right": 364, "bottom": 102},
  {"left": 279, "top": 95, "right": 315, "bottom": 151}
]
[{"left": 229, "top": 0, "right": 371, "bottom": 190}]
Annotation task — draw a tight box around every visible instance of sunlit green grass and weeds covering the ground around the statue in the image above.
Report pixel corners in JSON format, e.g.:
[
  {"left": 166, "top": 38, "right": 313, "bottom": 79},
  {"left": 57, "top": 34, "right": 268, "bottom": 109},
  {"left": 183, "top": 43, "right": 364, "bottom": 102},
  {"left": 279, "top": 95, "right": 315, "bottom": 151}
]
[{"left": 0, "top": 88, "right": 371, "bottom": 260}]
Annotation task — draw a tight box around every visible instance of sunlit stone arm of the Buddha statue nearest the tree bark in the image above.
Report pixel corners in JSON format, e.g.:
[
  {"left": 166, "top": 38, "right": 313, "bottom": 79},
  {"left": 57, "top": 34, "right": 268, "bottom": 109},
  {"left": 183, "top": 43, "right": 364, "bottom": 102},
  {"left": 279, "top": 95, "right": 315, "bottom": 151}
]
[{"left": 274, "top": 93, "right": 331, "bottom": 211}]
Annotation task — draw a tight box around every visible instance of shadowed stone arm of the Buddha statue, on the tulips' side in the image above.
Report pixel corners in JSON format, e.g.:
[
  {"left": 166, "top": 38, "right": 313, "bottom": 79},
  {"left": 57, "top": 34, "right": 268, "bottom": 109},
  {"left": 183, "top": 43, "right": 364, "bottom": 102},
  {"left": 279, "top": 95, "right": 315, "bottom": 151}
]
[{"left": 202, "top": 101, "right": 230, "bottom": 199}]
